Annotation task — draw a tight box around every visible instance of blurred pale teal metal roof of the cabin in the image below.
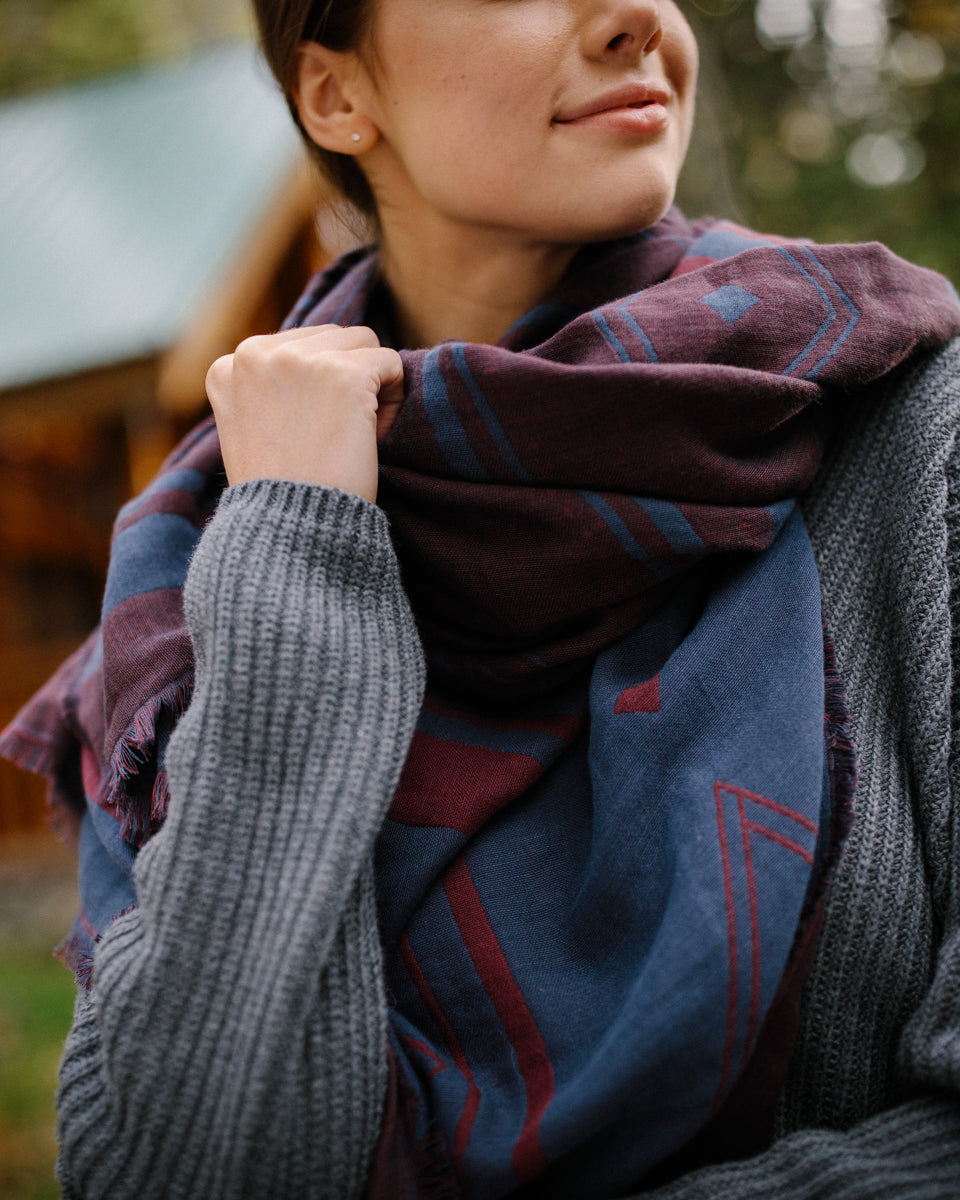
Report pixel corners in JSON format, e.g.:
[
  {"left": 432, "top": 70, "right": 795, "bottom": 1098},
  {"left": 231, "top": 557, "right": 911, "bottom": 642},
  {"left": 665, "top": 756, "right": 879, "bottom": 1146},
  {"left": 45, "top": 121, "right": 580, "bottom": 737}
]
[{"left": 0, "top": 43, "right": 299, "bottom": 389}]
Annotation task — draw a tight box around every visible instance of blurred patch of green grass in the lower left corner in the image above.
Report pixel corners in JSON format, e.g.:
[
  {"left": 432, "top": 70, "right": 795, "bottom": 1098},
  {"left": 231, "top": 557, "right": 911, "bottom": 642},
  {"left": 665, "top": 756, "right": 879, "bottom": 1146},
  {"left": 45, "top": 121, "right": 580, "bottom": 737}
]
[{"left": 0, "top": 948, "right": 74, "bottom": 1200}]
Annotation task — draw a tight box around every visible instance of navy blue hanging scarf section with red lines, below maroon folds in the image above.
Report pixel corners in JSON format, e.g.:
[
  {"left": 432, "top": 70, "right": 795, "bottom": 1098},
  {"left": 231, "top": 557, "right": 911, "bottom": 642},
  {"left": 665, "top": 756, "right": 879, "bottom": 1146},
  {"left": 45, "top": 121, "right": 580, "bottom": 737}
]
[{"left": 377, "top": 503, "right": 835, "bottom": 1196}]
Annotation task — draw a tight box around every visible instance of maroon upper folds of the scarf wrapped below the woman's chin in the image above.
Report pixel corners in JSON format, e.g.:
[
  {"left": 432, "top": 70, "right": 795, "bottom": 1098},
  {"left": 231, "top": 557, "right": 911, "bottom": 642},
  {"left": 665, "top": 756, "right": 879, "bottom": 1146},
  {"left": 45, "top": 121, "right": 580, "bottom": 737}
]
[{"left": 369, "top": 214, "right": 958, "bottom": 700}]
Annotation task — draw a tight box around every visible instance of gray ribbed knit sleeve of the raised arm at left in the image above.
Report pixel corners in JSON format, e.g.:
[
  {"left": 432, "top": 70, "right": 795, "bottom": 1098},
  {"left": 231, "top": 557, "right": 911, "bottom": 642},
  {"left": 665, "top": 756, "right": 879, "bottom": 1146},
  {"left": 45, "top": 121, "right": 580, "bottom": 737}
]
[{"left": 59, "top": 480, "right": 424, "bottom": 1200}]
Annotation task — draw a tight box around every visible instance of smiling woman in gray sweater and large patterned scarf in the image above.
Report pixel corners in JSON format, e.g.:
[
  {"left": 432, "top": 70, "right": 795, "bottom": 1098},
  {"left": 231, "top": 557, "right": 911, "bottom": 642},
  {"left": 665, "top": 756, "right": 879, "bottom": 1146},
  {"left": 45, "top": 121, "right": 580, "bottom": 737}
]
[{"left": 5, "top": 0, "right": 960, "bottom": 1200}]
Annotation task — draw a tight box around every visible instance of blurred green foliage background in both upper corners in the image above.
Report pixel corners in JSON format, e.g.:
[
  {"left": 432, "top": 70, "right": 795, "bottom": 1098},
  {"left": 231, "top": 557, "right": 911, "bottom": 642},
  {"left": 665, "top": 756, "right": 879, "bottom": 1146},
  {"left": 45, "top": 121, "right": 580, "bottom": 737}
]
[{"left": 0, "top": 0, "right": 960, "bottom": 281}]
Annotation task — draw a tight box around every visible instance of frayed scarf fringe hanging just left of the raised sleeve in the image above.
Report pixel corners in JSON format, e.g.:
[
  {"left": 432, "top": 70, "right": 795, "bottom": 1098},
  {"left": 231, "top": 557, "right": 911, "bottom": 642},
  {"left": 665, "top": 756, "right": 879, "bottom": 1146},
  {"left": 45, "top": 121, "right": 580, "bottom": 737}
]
[{"left": 103, "top": 679, "right": 193, "bottom": 847}]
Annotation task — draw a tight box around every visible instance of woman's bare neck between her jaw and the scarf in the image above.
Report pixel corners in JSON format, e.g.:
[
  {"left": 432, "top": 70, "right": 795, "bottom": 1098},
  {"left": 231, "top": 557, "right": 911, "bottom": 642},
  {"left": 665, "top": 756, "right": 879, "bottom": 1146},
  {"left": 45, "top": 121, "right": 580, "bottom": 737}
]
[{"left": 380, "top": 212, "right": 577, "bottom": 349}]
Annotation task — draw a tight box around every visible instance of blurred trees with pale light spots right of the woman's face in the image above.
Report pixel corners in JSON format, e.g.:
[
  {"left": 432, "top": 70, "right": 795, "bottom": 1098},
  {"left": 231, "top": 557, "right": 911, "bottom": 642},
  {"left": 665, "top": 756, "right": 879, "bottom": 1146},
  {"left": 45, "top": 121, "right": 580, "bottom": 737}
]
[{"left": 683, "top": 0, "right": 960, "bottom": 280}]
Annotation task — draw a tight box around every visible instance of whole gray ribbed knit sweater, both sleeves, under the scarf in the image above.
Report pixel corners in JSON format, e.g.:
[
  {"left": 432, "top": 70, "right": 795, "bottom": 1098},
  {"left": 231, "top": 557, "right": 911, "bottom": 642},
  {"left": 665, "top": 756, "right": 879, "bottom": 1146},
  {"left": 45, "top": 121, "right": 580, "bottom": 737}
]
[{"left": 59, "top": 342, "right": 960, "bottom": 1200}]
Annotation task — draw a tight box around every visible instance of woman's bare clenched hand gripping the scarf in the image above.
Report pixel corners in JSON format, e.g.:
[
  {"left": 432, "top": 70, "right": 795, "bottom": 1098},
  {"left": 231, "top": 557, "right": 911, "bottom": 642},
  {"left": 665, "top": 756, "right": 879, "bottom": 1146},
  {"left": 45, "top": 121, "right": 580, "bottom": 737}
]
[{"left": 206, "top": 325, "right": 403, "bottom": 500}]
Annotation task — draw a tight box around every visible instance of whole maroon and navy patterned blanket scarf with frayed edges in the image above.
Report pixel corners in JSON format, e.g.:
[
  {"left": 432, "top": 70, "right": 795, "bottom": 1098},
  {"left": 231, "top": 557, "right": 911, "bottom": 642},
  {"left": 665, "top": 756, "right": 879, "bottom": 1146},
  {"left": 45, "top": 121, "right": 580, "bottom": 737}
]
[{"left": 7, "top": 210, "right": 960, "bottom": 1200}]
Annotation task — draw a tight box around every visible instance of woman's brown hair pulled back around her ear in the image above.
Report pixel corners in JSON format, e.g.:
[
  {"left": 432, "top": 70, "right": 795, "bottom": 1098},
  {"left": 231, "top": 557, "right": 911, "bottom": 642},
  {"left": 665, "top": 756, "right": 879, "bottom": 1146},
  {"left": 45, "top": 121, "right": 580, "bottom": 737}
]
[{"left": 253, "top": 0, "right": 376, "bottom": 217}]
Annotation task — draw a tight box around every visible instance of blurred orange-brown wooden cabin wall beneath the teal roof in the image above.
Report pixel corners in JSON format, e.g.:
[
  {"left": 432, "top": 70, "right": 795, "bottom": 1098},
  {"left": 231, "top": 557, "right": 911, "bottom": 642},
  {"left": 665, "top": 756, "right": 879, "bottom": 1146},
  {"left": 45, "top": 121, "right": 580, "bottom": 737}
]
[{"left": 0, "top": 211, "right": 329, "bottom": 840}]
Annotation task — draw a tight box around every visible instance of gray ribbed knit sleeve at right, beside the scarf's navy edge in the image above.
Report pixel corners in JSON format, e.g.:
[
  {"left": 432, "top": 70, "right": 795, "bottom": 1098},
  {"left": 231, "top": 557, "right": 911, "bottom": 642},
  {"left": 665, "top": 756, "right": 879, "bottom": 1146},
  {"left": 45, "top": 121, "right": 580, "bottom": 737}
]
[{"left": 633, "top": 341, "right": 960, "bottom": 1200}]
